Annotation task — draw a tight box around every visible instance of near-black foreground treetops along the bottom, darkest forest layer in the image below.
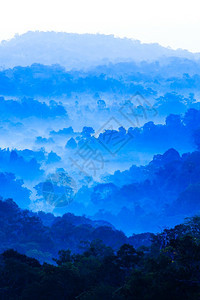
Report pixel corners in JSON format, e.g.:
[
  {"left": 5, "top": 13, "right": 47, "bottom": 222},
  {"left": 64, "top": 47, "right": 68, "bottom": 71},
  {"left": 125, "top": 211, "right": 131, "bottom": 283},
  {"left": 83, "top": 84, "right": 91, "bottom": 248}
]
[{"left": 0, "top": 216, "right": 200, "bottom": 300}]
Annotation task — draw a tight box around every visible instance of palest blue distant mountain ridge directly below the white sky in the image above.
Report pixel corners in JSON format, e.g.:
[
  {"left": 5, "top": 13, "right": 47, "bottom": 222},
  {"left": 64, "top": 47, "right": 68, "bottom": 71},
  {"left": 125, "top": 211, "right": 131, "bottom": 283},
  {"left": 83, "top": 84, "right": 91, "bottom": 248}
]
[{"left": 0, "top": 31, "right": 200, "bottom": 70}]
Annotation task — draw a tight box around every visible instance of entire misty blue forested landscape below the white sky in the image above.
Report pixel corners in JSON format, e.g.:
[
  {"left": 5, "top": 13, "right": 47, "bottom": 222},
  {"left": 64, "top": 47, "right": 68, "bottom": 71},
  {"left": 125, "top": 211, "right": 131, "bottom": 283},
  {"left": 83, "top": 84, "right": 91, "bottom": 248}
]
[{"left": 0, "top": 32, "right": 200, "bottom": 300}]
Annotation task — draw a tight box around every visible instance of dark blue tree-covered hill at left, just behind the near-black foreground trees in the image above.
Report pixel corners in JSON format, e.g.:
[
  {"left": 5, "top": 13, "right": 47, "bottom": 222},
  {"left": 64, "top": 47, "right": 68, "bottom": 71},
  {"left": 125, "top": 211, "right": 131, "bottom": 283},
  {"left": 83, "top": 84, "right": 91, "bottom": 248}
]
[{"left": 0, "top": 199, "right": 150, "bottom": 262}]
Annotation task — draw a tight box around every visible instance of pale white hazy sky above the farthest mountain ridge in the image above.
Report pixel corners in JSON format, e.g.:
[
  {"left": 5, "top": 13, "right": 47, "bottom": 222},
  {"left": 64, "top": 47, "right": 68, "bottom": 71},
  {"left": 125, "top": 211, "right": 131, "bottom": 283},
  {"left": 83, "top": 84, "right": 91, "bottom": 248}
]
[{"left": 0, "top": 0, "right": 200, "bottom": 52}]
